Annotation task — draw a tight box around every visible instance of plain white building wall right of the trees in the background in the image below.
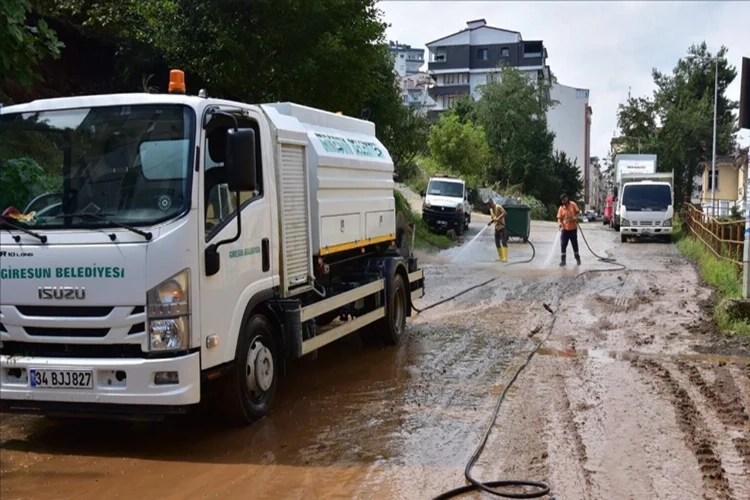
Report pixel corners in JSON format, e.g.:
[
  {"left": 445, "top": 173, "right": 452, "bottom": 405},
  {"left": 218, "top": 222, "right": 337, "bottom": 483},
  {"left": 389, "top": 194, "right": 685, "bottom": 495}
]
[{"left": 547, "top": 82, "right": 592, "bottom": 204}]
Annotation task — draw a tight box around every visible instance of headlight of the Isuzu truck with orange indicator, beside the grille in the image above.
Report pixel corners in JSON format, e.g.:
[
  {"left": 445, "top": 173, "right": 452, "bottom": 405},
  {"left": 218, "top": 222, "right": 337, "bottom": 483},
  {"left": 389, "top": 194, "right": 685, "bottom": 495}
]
[{"left": 146, "top": 269, "right": 190, "bottom": 352}]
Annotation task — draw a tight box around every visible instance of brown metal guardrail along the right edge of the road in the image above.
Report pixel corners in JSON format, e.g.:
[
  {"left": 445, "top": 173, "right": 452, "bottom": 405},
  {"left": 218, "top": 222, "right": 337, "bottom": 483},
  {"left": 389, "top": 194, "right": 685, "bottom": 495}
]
[{"left": 682, "top": 203, "right": 745, "bottom": 271}]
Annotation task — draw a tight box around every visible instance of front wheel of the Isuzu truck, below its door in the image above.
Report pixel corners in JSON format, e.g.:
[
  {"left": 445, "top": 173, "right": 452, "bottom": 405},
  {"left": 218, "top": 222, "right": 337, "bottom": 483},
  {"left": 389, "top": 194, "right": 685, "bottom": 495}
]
[{"left": 221, "top": 314, "right": 279, "bottom": 425}]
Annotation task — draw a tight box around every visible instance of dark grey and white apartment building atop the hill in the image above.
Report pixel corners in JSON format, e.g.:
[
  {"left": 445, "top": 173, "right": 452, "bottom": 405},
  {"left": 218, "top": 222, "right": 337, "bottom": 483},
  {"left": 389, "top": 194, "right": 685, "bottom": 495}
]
[{"left": 426, "top": 19, "right": 550, "bottom": 112}]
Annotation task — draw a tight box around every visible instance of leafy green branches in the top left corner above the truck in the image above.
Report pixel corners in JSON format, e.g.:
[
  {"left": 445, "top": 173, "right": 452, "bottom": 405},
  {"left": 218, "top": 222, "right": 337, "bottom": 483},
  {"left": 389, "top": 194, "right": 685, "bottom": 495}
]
[{"left": 0, "top": 0, "right": 63, "bottom": 88}]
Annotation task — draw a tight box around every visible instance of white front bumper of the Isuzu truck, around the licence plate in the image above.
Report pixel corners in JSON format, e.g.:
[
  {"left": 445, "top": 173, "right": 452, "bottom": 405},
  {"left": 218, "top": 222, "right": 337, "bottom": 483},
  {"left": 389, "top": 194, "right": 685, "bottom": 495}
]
[{"left": 0, "top": 352, "right": 200, "bottom": 413}]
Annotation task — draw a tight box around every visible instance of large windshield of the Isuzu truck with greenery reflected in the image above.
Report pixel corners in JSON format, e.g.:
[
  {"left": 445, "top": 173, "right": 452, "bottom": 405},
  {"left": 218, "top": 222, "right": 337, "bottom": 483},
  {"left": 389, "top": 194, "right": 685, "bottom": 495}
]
[{"left": 0, "top": 104, "right": 195, "bottom": 229}]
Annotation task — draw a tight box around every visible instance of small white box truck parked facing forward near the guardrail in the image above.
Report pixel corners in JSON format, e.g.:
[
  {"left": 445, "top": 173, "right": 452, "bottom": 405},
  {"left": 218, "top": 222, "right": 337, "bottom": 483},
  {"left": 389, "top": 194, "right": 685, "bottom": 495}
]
[{"left": 619, "top": 172, "right": 674, "bottom": 243}]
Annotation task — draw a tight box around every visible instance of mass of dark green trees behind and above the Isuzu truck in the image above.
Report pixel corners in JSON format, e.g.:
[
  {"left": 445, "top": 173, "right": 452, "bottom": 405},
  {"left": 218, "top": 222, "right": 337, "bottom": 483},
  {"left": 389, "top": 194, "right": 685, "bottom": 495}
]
[{"left": 22, "top": 0, "right": 427, "bottom": 174}]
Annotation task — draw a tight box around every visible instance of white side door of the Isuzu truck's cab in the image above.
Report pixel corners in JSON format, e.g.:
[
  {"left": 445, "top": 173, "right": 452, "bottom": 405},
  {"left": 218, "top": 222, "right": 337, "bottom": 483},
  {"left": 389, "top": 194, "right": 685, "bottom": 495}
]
[{"left": 197, "top": 110, "right": 278, "bottom": 369}]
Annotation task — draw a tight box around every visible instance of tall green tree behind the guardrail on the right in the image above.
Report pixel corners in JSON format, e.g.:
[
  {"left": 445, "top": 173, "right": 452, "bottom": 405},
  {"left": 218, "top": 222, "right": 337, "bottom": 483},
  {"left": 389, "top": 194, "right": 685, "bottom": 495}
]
[{"left": 618, "top": 42, "right": 737, "bottom": 205}]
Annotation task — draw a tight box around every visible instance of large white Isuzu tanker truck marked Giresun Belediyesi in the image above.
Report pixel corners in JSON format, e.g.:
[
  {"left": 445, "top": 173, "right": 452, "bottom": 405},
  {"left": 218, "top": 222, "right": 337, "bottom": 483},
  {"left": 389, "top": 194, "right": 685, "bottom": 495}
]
[{"left": 0, "top": 71, "right": 424, "bottom": 423}]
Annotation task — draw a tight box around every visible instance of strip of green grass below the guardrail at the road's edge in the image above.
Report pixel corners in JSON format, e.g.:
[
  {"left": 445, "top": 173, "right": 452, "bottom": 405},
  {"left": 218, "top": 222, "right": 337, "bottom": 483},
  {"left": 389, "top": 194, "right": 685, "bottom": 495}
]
[{"left": 673, "top": 223, "right": 750, "bottom": 335}]
